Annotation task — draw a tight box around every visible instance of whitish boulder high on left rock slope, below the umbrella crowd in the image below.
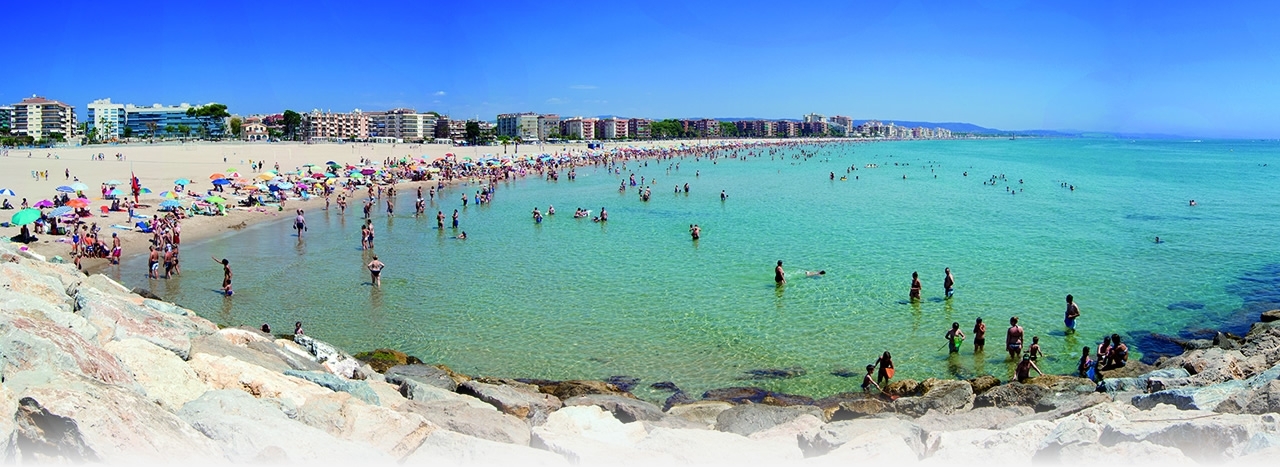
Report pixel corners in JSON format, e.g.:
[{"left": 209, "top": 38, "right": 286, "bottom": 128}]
[{"left": 76, "top": 289, "right": 218, "bottom": 360}]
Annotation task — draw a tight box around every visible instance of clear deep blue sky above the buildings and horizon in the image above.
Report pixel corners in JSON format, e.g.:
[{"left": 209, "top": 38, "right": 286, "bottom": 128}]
[{"left": 10, "top": 0, "right": 1280, "bottom": 138}]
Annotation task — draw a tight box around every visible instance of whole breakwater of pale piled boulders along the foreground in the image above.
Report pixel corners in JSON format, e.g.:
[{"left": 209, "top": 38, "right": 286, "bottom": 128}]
[{"left": 0, "top": 240, "right": 1280, "bottom": 464}]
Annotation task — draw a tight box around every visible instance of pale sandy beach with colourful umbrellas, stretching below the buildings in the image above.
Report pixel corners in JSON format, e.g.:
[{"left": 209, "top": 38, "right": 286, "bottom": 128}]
[{"left": 0, "top": 139, "right": 788, "bottom": 271}]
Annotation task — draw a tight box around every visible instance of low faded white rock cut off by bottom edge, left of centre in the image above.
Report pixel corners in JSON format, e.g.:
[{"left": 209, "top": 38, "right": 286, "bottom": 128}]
[{"left": 403, "top": 422, "right": 570, "bottom": 467}]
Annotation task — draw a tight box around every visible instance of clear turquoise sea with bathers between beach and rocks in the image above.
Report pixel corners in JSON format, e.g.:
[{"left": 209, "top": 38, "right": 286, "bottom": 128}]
[{"left": 113, "top": 139, "right": 1280, "bottom": 399}]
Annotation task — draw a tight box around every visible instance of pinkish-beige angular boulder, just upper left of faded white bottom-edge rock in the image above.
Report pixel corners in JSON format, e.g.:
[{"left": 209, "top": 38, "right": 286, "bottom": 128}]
[{"left": 293, "top": 393, "right": 436, "bottom": 459}]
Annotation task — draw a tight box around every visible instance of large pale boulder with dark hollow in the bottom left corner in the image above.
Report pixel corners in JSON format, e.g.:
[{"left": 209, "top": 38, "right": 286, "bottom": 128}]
[{"left": 15, "top": 375, "right": 221, "bottom": 463}]
